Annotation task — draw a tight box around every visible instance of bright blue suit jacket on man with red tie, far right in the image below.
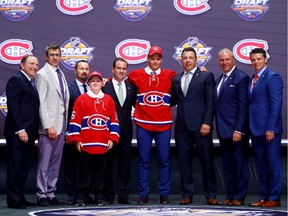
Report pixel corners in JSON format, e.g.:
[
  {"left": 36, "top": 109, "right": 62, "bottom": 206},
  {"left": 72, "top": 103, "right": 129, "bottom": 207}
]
[{"left": 248, "top": 67, "right": 283, "bottom": 136}]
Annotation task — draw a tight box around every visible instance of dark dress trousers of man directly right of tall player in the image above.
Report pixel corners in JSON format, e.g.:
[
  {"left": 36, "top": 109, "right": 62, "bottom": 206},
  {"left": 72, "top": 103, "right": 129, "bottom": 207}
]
[{"left": 175, "top": 128, "right": 217, "bottom": 199}]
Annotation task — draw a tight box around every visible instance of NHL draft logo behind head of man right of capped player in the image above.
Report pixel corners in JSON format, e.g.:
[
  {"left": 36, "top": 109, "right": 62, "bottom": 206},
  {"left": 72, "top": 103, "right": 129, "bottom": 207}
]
[{"left": 173, "top": 37, "right": 212, "bottom": 67}]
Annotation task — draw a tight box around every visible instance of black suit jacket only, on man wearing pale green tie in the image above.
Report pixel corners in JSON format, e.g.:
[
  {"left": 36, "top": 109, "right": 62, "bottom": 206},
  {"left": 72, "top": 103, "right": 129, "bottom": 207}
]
[{"left": 102, "top": 80, "right": 137, "bottom": 140}]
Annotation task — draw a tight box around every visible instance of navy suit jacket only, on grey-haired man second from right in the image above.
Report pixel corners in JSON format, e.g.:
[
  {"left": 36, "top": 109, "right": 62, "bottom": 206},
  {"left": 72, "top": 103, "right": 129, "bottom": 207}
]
[{"left": 214, "top": 68, "right": 250, "bottom": 138}]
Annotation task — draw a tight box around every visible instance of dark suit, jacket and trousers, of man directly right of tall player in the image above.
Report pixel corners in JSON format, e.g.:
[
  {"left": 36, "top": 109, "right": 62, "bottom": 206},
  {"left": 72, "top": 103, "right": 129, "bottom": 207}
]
[{"left": 172, "top": 68, "right": 216, "bottom": 199}]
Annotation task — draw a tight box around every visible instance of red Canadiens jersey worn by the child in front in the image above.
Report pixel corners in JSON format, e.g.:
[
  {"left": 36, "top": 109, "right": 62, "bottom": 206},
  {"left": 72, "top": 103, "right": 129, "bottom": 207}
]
[{"left": 68, "top": 93, "right": 119, "bottom": 154}]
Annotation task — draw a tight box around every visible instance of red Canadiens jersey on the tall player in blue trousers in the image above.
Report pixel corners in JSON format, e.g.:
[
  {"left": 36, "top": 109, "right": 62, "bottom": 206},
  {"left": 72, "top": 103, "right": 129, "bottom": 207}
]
[{"left": 128, "top": 68, "right": 177, "bottom": 132}]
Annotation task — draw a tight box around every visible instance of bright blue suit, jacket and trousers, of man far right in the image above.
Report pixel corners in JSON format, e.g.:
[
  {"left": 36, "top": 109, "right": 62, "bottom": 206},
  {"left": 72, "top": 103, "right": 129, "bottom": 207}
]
[{"left": 248, "top": 67, "right": 283, "bottom": 201}]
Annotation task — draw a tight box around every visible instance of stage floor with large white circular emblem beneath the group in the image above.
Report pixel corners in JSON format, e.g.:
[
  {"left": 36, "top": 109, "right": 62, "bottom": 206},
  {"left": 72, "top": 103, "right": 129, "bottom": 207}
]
[{"left": 0, "top": 194, "right": 288, "bottom": 216}]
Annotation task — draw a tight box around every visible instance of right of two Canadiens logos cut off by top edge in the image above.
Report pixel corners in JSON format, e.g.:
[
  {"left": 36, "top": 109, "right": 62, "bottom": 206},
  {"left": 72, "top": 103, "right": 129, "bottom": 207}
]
[{"left": 173, "top": 0, "right": 210, "bottom": 15}]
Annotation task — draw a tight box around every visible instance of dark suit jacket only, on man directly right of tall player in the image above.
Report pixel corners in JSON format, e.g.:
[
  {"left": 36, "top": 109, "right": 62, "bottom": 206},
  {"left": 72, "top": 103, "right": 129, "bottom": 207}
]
[{"left": 172, "top": 68, "right": 215, "bottom": 132}]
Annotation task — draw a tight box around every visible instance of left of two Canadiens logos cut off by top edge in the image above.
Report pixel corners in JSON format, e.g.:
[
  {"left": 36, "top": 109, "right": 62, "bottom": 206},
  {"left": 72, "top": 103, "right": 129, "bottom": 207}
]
[{"left": 56, "top": 0, "right": 93, "bottom": 15}]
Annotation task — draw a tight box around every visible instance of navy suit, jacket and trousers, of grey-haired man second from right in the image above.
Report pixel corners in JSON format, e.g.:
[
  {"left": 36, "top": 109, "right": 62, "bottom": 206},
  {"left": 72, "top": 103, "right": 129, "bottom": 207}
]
[{"left": 214, "top": 68, "right": 250, "bottom": 202}]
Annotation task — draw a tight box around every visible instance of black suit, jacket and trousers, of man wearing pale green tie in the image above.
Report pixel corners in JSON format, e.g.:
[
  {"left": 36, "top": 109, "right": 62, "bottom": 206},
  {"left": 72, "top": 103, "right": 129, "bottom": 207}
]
[{"left": 102, "top": 81, "right": 137, "bottom": 203}]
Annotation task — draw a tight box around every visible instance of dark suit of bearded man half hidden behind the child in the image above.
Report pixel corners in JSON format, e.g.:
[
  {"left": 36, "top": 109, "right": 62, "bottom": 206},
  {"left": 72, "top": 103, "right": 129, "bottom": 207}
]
[{"left": 63, "top": 80, "right": 81, "bottom": 201}]
